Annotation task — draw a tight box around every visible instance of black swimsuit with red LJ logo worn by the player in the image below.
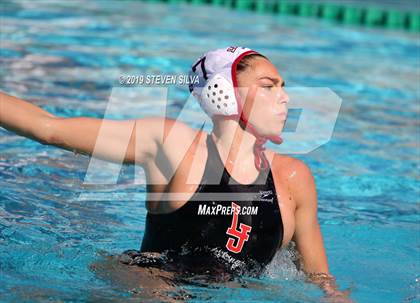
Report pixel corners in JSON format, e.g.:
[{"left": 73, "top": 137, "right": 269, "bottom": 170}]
[{"left": 122, "top": 135, "right": 283, "bottom": 275}]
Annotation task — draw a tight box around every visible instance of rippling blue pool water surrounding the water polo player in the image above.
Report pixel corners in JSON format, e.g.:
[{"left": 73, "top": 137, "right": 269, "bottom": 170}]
[{"left": 0, "top": 1, "right": 420, "bottom": 302}]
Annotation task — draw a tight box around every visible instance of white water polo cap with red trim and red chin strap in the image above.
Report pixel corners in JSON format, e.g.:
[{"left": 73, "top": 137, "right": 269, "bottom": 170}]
[{"left": 189, "top": 46, "right": 283, "bottom": 170}]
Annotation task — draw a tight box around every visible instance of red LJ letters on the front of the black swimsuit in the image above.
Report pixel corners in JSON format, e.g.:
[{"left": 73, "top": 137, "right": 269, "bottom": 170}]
[{"left": 226, "top": 202, "right": 252, "bottom": 254}]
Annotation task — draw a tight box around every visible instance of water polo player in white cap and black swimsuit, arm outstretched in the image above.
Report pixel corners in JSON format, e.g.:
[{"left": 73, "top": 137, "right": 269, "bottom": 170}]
[{"left": 0, "top": 47, "right": 349, "bottom": 302}]
